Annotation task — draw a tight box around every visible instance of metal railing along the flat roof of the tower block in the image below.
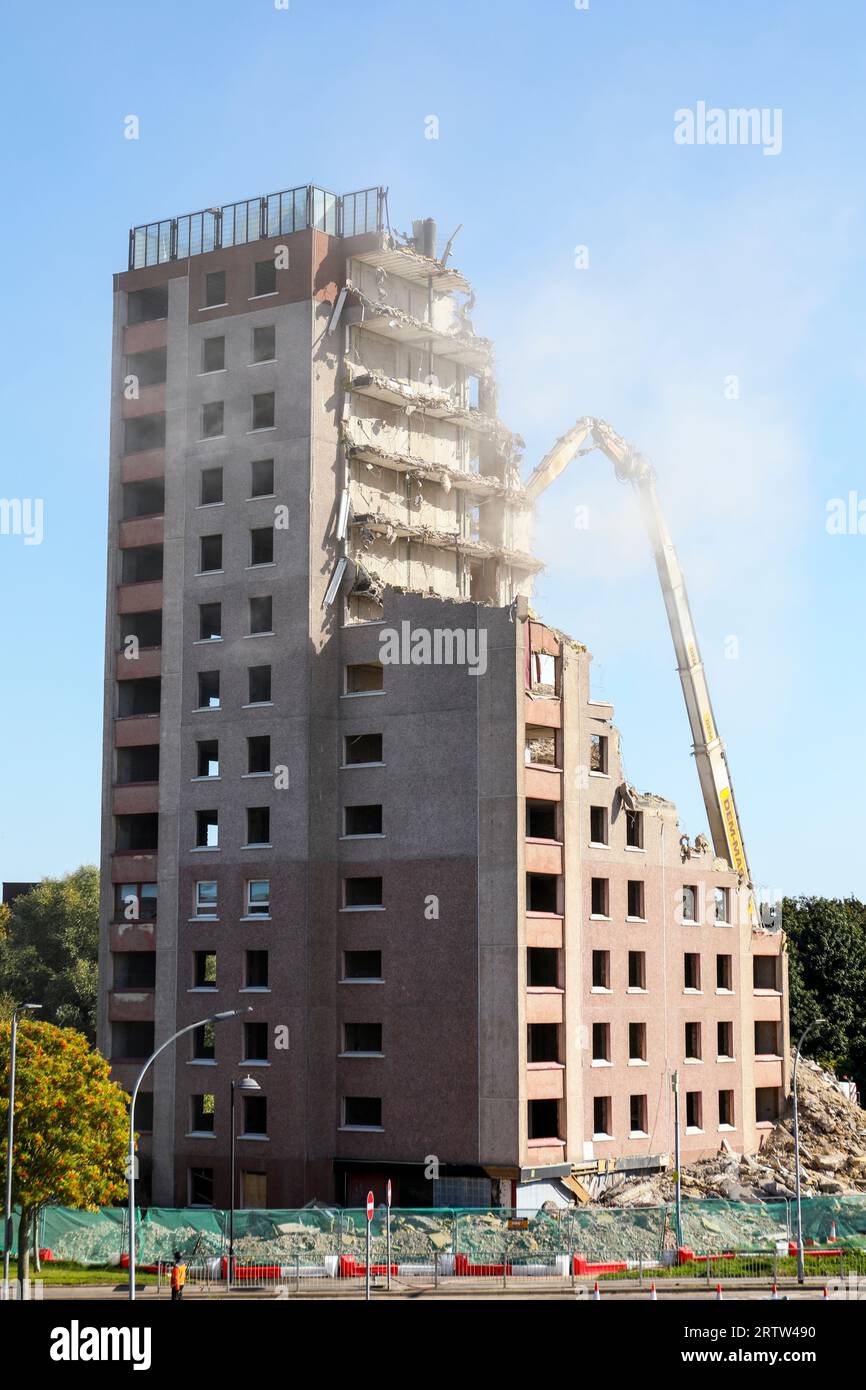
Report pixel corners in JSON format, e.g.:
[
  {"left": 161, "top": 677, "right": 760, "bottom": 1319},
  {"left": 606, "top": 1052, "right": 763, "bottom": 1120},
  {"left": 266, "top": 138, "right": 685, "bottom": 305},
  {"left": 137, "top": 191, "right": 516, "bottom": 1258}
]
[{"left": 129, "top": 183, "right": 386, "bottom": 270}]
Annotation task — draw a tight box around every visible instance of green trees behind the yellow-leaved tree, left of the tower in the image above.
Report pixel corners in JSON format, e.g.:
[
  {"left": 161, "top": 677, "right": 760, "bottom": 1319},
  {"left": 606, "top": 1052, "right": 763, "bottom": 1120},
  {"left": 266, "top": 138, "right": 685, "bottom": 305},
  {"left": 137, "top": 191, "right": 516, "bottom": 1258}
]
[{"left": 0, "top": 865, "right": 99, "bottom": 1043}]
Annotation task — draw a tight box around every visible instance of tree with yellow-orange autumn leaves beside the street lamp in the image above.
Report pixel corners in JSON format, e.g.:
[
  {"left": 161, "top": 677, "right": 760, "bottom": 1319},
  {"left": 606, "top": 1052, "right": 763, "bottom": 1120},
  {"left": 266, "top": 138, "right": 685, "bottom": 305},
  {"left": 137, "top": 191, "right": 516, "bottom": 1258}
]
[{"left": 0, "top": 1017, "right": 128, "bottom": 1287}]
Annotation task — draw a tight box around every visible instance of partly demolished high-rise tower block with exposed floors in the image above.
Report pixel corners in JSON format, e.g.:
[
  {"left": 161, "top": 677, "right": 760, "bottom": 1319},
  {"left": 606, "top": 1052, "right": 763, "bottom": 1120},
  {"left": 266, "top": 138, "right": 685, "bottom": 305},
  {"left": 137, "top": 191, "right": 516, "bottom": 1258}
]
[{"left": 100, "top": 188, "right": 787, "bottom": 1208}]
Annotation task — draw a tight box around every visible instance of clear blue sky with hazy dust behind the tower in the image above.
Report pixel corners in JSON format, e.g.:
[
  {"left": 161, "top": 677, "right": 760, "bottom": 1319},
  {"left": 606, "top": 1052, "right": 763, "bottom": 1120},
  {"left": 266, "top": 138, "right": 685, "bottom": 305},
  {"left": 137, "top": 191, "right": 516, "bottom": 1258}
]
[{"left": 0, "top": 0, "right": 866, "bottom": 897}]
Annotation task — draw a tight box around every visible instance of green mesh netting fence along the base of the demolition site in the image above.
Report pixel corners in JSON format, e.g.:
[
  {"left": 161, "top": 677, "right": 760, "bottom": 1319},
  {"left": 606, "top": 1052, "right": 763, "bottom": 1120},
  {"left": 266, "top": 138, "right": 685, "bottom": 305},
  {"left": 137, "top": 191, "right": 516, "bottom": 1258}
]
[{"left": 8, "top": 1197, "right": 866, "bottom": 1266}]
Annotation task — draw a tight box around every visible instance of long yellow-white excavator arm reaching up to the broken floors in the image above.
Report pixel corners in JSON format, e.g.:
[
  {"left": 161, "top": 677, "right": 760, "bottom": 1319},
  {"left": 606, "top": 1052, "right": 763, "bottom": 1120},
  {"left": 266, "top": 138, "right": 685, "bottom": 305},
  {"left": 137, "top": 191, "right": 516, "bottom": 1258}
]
[{"left": 527, "top": 416, "right": 758, "bottom": 906}]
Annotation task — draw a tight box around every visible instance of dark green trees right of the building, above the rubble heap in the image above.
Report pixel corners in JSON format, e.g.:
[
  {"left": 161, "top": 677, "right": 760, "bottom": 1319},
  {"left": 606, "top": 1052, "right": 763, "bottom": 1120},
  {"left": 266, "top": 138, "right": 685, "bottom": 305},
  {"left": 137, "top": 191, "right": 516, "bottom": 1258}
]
[{"left": 783, "top": 898, "right": 866, "bottom": 1093}]
